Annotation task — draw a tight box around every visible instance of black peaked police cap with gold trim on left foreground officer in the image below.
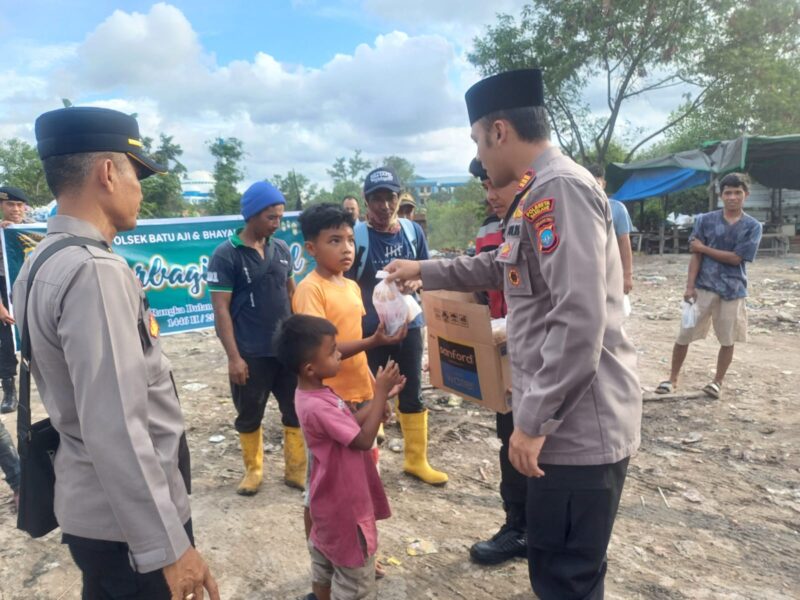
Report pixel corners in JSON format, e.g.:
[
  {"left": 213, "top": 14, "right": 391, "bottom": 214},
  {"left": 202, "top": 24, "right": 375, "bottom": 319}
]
[{"left": 36, "top": 106, "right": 167, "bottom": 177}]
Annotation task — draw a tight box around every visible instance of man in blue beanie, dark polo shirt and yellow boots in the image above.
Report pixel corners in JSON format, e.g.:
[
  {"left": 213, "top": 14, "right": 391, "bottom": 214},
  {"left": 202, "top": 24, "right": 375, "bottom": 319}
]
[{"left": 208, "top": 181, "right": 306, "bottom": 496}]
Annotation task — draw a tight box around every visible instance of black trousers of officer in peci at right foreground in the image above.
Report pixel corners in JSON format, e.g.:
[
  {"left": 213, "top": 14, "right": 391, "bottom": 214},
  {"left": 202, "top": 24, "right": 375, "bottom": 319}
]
[{"left": 528, "top": 458, "right": 628, "bottom": 600}]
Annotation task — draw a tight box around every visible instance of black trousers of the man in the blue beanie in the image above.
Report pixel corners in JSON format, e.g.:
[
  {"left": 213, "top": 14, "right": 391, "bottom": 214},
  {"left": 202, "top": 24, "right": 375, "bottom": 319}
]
[{"left": 231, "top": 356, "right": 300, "bottom": 433}]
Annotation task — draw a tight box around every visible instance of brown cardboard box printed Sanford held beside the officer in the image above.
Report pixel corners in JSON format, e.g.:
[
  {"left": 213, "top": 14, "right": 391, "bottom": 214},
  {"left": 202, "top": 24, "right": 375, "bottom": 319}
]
[{"left": 422, "top": 291, "right": 511, "bottom": 414}]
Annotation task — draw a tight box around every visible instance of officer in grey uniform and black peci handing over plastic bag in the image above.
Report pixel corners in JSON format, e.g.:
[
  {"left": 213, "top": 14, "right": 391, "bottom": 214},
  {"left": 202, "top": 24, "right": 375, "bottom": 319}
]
[{"left": 386, "top": 69, "right": 642, "bottom": 600}]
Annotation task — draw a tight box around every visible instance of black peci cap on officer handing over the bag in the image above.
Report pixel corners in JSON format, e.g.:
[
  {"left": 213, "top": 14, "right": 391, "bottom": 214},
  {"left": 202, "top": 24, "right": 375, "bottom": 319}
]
[{"left": 464, "top": 69, "right": 544, "bottom": 125}]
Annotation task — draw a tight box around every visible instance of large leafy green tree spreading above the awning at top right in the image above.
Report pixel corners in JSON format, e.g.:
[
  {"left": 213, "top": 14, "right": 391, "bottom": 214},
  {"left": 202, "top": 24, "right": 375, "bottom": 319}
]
[{"left": 470, "top": 0, "right": 800, "bottom": 163}]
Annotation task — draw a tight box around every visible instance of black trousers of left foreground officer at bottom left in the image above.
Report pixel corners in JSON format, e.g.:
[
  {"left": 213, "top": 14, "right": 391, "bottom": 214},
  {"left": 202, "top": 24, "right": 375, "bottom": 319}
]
[{"left": 61, "top": 519, "right": 194, "bottom": 600}]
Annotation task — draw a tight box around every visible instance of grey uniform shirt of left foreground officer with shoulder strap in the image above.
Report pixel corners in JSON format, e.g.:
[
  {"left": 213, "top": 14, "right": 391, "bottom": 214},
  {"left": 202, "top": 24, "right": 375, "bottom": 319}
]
[{"left": 14, "top": 216, "right": 191, "bottom": 572}]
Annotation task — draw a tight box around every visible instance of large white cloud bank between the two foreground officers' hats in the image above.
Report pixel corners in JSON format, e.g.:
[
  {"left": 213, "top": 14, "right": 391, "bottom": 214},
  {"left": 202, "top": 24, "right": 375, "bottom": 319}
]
[{"left": 18, "top": 4, "right": 475, "bottom": 183}]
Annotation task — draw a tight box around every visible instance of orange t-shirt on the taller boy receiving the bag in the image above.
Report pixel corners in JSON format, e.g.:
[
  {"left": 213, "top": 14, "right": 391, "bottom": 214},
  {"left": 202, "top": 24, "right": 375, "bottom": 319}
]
[{"left": 292, "top": 271, "right": 373, "bottom": 402}]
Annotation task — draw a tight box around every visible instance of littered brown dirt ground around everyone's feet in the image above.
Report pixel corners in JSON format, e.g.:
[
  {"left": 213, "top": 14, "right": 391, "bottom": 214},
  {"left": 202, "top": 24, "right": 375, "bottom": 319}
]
[{"left": 0, "top": 255, "right": 800, "bottom": 600}]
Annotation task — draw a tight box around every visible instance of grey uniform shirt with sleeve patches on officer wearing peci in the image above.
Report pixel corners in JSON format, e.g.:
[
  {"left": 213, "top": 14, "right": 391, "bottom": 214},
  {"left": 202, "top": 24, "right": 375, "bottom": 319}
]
[{"left": 422, "top": 148, "right": 642, "bottom": 465}]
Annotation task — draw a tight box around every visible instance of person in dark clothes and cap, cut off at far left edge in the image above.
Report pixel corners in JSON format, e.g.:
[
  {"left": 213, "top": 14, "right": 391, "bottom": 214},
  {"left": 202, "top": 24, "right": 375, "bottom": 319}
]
[{"left": 0, "top": 185, "right": 28, "bottom": 414}]
